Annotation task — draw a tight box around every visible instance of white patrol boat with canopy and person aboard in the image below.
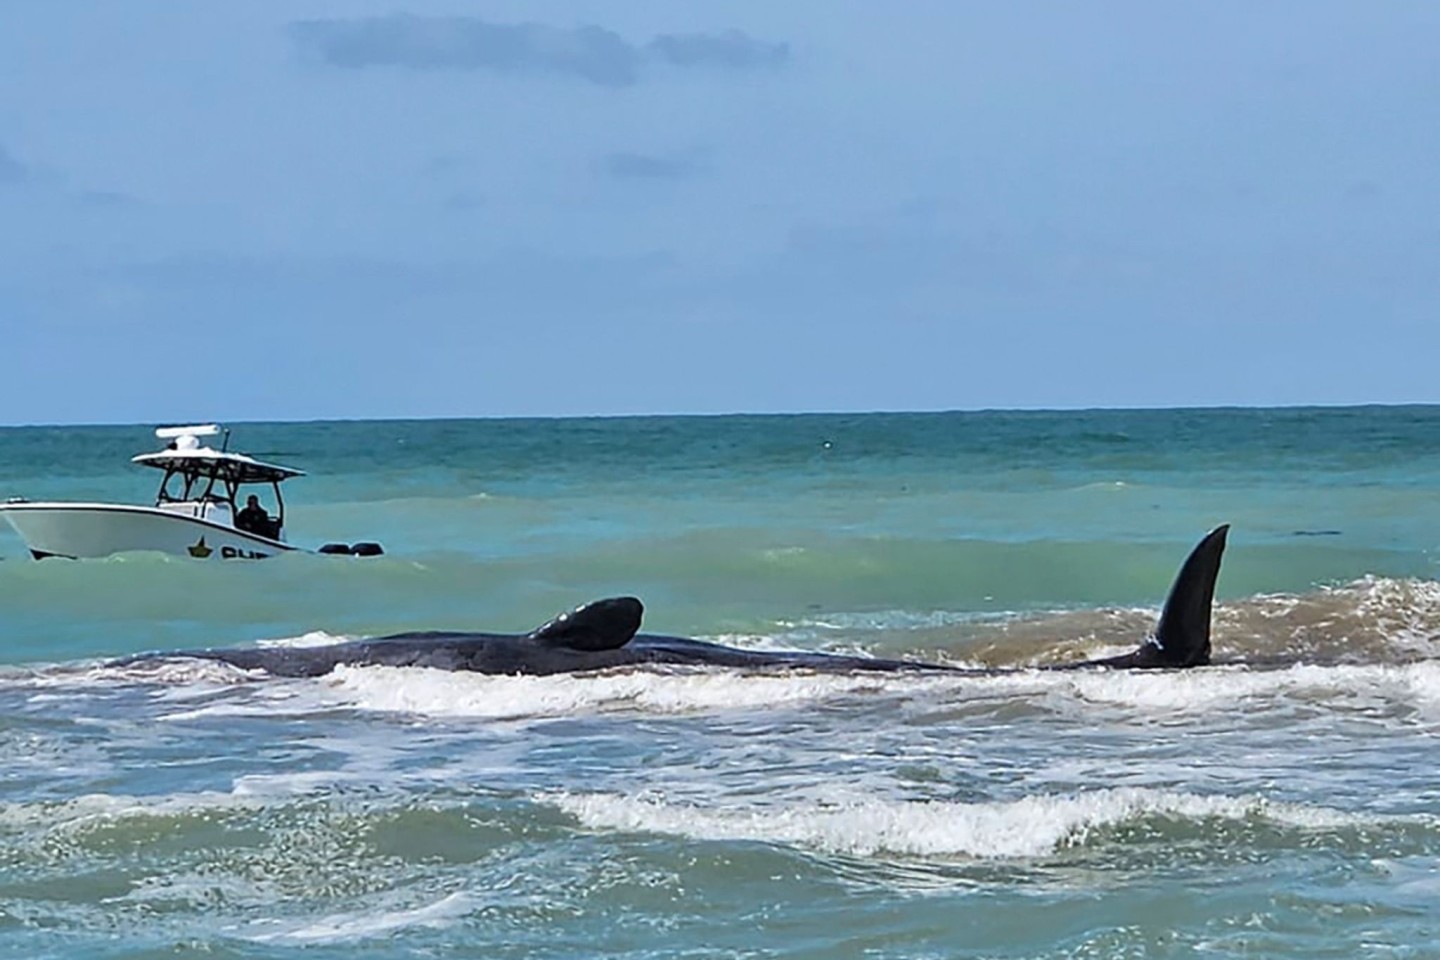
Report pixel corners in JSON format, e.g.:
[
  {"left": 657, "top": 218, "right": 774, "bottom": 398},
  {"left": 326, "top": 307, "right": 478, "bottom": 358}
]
[{"left": 0, "top": 423, "right": 382, "bottom": 560}]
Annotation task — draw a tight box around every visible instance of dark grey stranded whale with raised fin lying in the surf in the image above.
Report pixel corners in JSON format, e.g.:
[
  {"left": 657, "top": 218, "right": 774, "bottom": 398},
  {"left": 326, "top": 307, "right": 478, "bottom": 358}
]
[{"left": 135, "top": 525, "right": 1230, "bottom": 676}]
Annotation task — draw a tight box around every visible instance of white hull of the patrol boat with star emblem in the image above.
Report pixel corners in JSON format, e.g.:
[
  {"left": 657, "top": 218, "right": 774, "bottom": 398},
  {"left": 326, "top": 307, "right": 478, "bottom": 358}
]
[{"left": 0, "top": 502, "right": 295, "bottom": 560}]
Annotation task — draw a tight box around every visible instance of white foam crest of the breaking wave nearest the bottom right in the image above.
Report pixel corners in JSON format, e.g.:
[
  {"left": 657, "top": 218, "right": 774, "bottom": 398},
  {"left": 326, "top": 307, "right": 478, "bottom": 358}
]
[{"left": 539, "top": 787, "right": 1367, "bottom": 859}]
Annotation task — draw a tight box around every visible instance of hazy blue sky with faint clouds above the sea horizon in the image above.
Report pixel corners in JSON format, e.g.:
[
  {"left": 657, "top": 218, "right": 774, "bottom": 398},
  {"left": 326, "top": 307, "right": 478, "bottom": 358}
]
[{"left": 0, "top": 0, "right": 1440, "bottom": 425}]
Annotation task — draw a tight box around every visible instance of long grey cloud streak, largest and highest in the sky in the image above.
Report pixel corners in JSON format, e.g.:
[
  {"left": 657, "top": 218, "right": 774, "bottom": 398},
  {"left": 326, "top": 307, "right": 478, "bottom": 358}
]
[{"left": 289, "top": 14, "right": 789, "bottom": 88}]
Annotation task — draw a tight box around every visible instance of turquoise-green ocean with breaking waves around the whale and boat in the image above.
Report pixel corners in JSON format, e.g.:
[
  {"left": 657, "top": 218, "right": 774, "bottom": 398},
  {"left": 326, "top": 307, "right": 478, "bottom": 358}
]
[{"left": 0, "top": 406, "right": 1440, "bottom": 960}]
